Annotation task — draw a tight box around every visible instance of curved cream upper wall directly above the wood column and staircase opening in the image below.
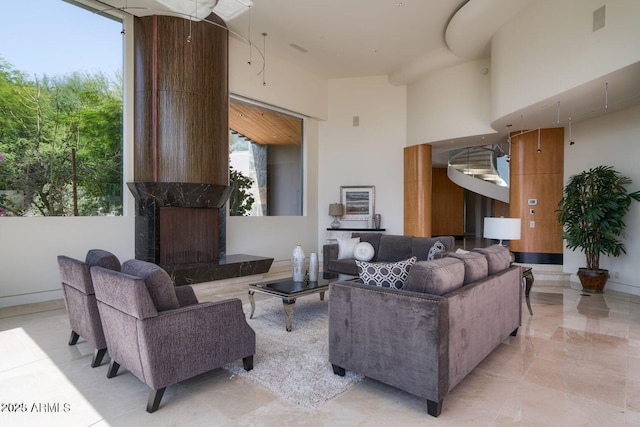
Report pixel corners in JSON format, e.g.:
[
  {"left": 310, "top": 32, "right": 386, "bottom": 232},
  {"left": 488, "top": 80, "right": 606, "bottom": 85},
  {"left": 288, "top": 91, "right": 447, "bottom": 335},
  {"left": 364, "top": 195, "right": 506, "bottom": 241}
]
[{"left": 407, "top": 59, "right": 495, "bottom": 146}]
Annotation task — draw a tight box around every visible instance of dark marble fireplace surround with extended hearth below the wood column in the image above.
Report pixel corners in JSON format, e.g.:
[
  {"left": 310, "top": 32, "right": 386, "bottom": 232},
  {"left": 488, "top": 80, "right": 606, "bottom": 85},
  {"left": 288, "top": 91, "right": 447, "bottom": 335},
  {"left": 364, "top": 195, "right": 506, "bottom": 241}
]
[{"left": 127, "top": 182, "right": 273, "bottom": 285}]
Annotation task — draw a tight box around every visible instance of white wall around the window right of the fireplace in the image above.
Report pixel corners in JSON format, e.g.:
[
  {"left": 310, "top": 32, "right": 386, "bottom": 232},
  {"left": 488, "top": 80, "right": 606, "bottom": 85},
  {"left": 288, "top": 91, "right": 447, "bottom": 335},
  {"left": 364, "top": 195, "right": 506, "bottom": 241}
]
[{"left": 227, "top": 38, "right": 327, "bottom": 268}]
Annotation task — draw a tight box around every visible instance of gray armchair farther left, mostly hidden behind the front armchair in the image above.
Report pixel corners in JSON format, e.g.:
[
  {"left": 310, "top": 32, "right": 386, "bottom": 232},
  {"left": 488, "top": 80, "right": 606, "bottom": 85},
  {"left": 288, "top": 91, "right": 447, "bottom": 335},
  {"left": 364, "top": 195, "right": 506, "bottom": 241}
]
[{"left": 58, "top": 249, "right": 120, "bottom": 368}]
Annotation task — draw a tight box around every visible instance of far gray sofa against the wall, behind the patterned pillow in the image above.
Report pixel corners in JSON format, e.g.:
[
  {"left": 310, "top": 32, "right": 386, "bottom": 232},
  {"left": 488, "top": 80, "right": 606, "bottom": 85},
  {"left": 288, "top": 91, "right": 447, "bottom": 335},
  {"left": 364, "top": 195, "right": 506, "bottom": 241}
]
[{"left": 322, "top": 233, "right": 455, "bottom": 276}]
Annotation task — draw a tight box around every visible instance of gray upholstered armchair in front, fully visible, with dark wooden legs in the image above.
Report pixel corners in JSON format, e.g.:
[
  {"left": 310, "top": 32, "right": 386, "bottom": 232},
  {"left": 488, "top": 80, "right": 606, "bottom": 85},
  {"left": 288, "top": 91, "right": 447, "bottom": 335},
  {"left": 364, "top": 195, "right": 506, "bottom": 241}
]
[{"left": 91, "top": 260, "right": 256, "bottom": 412}]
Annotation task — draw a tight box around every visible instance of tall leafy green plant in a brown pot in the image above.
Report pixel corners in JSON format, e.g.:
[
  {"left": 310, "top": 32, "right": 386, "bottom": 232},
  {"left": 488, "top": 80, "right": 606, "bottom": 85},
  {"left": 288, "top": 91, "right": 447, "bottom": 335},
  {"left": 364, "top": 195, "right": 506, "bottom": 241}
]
[{"left": 557, "top": 166, "right": 640, "bottom": 292}]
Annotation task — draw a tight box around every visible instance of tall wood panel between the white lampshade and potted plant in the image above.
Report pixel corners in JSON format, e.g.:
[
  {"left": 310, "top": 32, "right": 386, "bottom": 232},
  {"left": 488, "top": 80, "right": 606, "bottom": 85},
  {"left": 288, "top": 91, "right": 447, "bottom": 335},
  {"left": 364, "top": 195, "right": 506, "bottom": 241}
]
[{"left": 509, "top": 128, "right": 564, "bottom": 254}]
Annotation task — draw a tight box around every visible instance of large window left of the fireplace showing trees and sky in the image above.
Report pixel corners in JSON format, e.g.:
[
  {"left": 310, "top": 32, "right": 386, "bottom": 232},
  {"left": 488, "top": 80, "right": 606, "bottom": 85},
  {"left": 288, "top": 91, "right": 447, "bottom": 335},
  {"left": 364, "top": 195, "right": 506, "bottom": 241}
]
[{"left": 0, "top": 0, "right": 123, "bottom": 216}]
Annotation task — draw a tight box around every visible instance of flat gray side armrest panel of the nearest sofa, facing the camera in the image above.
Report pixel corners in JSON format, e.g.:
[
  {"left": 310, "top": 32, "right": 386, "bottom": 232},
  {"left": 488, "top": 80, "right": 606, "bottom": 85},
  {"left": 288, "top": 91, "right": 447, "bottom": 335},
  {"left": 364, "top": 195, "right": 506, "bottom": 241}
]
[{"left": 329, "top": 282, "right": 449, "bottom": 402}]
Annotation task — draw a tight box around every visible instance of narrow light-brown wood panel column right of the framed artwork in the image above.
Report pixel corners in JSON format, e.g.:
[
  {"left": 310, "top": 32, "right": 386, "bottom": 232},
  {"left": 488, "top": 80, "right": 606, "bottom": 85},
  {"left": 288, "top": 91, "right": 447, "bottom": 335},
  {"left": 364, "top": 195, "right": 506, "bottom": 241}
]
[{"left": 404, "top": 144, "right": 432, "bottom": 237}]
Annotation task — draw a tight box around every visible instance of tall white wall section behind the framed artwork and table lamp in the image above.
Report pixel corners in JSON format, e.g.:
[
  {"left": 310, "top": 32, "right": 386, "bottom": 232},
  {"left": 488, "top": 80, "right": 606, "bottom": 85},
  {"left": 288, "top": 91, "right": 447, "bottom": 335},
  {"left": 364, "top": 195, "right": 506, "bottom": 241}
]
[{"left": 318, "top": 76, "right": 406, "bottom": 250}]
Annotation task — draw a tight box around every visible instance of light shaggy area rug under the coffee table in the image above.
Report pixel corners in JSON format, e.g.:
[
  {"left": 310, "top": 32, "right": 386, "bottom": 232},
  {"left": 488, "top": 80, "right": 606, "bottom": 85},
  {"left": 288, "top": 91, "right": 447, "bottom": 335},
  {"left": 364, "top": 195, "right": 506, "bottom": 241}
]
[{"left": 225, "top": 294, "right": 363, "bottom": 409}]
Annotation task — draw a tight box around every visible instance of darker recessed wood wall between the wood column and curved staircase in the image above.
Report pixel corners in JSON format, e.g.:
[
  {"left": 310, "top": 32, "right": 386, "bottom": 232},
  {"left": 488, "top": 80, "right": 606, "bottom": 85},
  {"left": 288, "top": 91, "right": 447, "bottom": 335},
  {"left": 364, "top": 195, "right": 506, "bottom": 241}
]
[{"left": 431, "top": 168, "right": 464, "bottom": 236}]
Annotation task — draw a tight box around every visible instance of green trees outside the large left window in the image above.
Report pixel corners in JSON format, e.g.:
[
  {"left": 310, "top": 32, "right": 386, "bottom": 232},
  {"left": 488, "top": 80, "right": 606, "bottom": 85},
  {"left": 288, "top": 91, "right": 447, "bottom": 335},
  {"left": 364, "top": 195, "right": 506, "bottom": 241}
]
[{"left": 0, "top": 60, "right": 122, "bottom": 216}]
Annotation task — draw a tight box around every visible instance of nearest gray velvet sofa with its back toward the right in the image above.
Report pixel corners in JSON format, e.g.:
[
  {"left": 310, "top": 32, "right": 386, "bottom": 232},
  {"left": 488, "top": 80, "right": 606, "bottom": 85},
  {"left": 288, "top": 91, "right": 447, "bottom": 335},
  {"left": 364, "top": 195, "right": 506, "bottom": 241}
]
[{"left": 329, "top": 245, "right": 522, "bottom": 416}]
